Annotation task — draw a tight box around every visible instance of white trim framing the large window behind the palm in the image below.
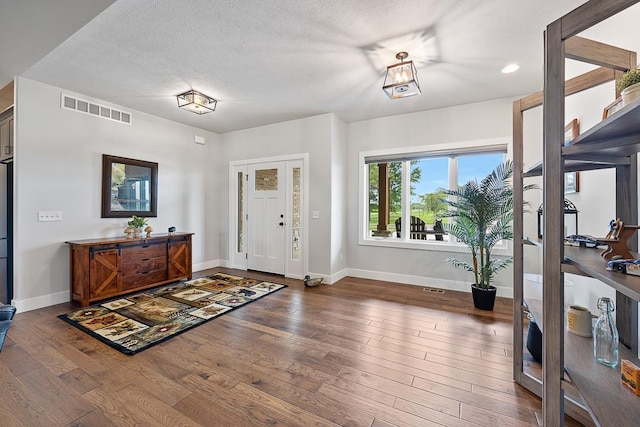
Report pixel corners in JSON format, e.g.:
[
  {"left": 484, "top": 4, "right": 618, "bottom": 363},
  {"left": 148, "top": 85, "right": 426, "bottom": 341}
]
[{"left": 358, "top": 137, "right": 513, "bottom": 256}]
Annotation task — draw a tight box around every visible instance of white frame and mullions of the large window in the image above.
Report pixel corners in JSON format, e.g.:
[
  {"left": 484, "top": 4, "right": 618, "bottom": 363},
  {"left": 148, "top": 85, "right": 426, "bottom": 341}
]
[{"left": 358, "top": 137, "right": 513, "bottom": 256}]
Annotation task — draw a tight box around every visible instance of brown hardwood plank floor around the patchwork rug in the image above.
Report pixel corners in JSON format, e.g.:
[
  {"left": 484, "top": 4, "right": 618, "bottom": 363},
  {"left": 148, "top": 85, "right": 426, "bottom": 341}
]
[{"left": 0, "top": 268, "right": 570, "bottom": 427}]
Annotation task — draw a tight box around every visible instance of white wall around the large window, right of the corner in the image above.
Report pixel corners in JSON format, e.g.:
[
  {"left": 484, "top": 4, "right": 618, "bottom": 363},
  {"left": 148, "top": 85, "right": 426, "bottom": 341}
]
[{"left": 347, "top": 99, "right": 513, "bottom": 295}]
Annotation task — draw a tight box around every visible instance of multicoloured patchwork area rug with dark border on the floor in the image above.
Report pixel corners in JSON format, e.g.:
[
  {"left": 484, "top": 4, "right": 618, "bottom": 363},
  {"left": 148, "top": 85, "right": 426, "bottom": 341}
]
[{"left": 58, "top": 273, "right": 286, "bottom": 354}]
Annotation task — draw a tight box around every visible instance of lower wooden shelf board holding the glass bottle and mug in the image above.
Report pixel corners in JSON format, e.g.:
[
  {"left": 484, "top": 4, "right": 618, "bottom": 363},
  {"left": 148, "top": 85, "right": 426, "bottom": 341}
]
[{"left": 564, "top": 328, "right": 640, "bottom": 426}]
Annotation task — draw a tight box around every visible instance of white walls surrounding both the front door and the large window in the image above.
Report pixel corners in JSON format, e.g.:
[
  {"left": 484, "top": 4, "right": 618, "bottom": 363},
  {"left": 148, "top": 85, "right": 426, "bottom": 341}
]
[{"left": 215, "top": 99, "right": 512, "bottom": 295}]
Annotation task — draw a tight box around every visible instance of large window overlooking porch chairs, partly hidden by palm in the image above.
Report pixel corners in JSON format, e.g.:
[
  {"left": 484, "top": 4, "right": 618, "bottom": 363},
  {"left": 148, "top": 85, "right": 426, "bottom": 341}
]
[{"left": 361, "top": 142, "right": 507, "bottom": 245}]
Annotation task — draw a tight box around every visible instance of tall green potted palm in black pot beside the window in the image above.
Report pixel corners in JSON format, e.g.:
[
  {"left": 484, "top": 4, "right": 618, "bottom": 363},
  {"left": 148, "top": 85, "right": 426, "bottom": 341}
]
[{"left": 443, "top": 161, "right": 535, "bottom": 310}]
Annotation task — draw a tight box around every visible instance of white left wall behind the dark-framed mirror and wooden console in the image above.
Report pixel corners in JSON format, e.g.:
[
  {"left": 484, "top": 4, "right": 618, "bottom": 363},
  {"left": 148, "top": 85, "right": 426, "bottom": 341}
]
[{"left": 13, "top": 78, "right": 220, "bottom": 310}]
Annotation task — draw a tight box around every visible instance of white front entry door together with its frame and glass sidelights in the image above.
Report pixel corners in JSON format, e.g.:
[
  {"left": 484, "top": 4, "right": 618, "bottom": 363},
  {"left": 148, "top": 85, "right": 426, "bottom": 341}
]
[{"left": 229, "top": 154, "right": 308, "bottom": 278}]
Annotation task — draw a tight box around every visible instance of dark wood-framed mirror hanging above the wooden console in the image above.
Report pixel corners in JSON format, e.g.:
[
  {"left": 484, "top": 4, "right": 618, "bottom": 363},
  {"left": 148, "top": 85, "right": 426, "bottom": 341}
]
[{"left": 102, "top": 154, "right": 158, "bottom": 218}]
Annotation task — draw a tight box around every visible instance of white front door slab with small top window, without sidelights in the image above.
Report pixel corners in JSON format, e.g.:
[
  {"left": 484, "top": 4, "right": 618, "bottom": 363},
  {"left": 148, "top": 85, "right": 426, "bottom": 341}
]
[{"left": 246, "top": 162, "right": 286, "bottom": 274}]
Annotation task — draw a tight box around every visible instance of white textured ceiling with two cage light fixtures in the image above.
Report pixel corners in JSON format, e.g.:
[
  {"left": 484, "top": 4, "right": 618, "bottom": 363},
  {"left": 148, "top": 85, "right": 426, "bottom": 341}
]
[{"left": 0, "top": 0, "right": 612, "bottom": 133}]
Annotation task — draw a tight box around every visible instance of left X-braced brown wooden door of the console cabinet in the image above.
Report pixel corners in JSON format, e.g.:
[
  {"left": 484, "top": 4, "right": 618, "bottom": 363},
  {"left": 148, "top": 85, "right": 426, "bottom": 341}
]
[{"left": 89, "top": 249, "right": 120, "bottom": 299}]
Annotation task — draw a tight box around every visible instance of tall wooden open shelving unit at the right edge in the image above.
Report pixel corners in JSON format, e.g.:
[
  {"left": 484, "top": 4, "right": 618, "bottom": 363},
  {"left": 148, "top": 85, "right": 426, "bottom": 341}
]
[{"left": 513, "top": 0, "right": 640, "bottom": 426}]
